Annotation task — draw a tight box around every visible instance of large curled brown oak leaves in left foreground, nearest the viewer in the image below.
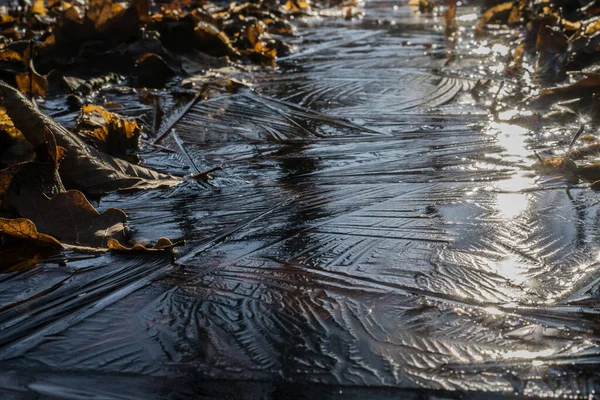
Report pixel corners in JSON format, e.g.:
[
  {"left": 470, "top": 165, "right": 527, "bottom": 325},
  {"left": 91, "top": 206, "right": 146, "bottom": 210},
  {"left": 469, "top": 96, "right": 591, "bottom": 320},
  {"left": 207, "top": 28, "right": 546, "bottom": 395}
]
[{"left": 0, "top": 83, "right": 180, "bottom": 271}]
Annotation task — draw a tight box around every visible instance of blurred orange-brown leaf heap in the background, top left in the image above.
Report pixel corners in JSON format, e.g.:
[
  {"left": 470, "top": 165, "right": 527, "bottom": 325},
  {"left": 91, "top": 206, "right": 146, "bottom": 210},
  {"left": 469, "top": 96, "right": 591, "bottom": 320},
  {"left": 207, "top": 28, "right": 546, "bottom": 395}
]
[{"left": 0, "top": 0, "right": 360, "bottom": 96}]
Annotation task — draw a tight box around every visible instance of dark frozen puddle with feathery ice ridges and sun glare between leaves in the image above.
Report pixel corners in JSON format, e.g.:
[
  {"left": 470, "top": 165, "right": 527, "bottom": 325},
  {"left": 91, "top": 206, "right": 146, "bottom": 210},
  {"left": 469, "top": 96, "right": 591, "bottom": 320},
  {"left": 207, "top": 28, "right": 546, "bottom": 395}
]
[{"left": 0, "top": 1, "right": 600, "bottom": 399}]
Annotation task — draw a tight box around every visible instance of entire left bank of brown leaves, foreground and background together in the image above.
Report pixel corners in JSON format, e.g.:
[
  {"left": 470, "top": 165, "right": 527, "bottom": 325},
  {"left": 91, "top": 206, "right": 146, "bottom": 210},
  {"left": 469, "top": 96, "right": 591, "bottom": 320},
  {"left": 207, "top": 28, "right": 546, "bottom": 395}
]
[{"left": 0, "top": 0, "right": 360, "bottom": 272}]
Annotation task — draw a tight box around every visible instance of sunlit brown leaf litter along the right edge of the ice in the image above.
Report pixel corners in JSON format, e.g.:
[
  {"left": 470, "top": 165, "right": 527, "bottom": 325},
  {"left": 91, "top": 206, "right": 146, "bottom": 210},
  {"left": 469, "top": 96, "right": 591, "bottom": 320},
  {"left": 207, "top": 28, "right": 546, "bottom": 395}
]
[{"left": 468, "top": 0, "right": 600, "bottom": 189}]
